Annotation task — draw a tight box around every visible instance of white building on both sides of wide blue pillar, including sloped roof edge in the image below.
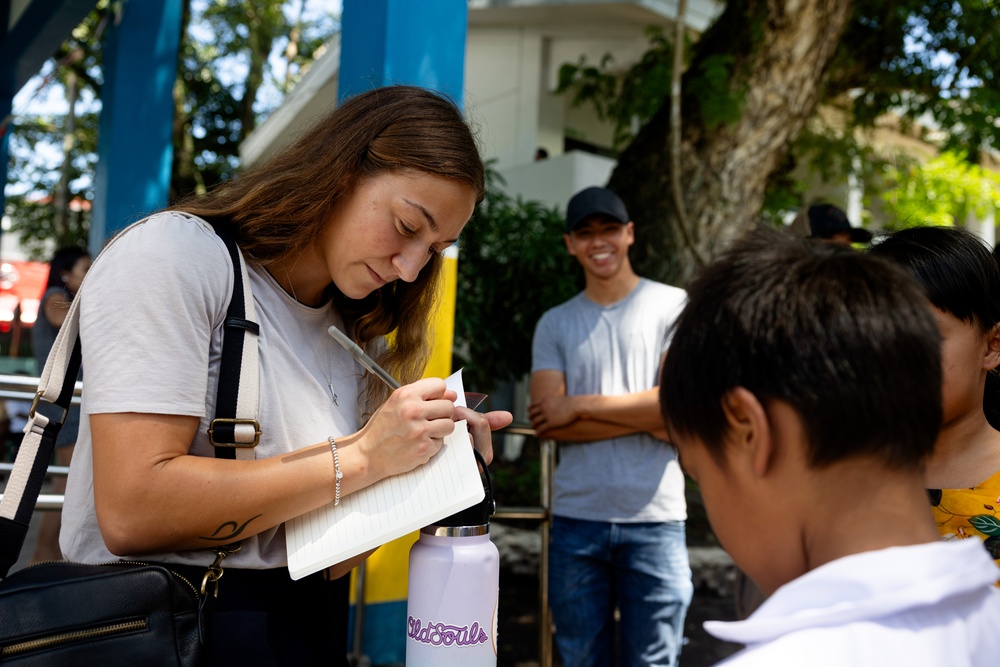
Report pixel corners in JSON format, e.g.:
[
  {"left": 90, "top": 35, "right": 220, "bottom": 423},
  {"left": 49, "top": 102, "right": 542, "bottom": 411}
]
[{"left": 240, "top": 0, "right": 723, "bottom": 203}]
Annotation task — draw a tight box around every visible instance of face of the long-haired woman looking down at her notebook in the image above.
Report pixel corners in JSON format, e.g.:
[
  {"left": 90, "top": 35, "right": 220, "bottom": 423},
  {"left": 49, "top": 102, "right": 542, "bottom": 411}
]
[{"left": 316, "top": 170, "right": 476, "bottom": 299}]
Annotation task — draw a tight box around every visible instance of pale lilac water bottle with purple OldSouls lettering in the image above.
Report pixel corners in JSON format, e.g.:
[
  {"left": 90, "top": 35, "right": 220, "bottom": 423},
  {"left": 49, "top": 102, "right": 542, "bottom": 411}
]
[{"left": 406, "top": 452, "right": 500, "bottom": 667}]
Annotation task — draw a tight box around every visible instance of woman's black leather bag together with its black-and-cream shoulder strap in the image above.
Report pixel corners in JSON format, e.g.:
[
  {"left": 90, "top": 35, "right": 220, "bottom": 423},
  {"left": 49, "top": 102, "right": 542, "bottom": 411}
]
[{"left": 0, "top": 218, "right": 259, "bottom": 667}]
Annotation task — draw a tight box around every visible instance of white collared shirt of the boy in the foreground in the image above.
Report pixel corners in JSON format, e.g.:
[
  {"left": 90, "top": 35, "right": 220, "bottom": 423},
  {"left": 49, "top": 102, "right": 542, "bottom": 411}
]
[{"left": 705, "top": 540, "right": 1000, "bottom": 667}]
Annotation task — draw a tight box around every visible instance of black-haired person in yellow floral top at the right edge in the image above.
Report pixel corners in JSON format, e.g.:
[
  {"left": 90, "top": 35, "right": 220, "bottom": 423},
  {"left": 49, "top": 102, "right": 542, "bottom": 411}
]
[{"left": 869, "top": 227, "right": 1000, "bottom": 565}]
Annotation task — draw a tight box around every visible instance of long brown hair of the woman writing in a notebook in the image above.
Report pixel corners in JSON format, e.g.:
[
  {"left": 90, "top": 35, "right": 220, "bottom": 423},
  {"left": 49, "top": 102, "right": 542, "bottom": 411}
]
[{"left": 170, "top": 86, "right": 486, "bottom": 410}]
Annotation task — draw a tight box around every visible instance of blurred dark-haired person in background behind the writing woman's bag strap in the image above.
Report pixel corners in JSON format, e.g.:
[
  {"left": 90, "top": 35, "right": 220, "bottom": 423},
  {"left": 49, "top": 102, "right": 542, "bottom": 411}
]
[{"left": 31, "top": 246, "right": 91, "bottom": 563}]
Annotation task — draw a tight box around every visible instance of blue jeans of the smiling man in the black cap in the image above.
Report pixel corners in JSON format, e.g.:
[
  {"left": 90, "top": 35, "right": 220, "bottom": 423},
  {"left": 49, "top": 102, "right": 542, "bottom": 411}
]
[{"left": 549, "top": 516, "right": 694, "bottom": 667}]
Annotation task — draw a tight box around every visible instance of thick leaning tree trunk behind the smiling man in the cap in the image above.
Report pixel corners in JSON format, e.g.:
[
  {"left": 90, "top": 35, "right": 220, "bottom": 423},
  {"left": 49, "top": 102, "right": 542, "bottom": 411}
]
[{"left": 609, "top": 0, "right": 851, "bottom": 285}]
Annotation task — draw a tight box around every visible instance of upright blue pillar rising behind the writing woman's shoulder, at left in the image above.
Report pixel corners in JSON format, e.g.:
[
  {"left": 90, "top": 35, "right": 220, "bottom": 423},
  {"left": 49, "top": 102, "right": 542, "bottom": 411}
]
[{"left": 90, "top": 0, "right": 182, "bottom": 256}]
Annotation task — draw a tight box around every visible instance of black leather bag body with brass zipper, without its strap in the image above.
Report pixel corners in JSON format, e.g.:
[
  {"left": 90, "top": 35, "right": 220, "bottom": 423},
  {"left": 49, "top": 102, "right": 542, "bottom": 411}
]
[{"left": 0, "top": 562, "right": 207, "bottom": 667}]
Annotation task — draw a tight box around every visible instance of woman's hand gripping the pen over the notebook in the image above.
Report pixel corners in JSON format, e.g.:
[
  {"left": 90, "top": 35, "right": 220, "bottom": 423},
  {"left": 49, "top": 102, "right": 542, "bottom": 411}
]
[{"left": 357, "top": 378, "right": 458, "bottom": 478}]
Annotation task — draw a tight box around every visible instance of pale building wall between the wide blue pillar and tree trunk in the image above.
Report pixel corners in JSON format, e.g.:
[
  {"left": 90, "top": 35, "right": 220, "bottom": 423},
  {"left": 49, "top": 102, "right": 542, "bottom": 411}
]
[{"left": 464, "top": 8, "right": 692, "bottom": 209}]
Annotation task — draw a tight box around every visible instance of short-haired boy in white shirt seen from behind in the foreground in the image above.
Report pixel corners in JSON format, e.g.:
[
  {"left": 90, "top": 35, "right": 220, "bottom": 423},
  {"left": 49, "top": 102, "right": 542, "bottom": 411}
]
[{"left": 660, "top": 230, "right": 1000, "bottom": 666}]
